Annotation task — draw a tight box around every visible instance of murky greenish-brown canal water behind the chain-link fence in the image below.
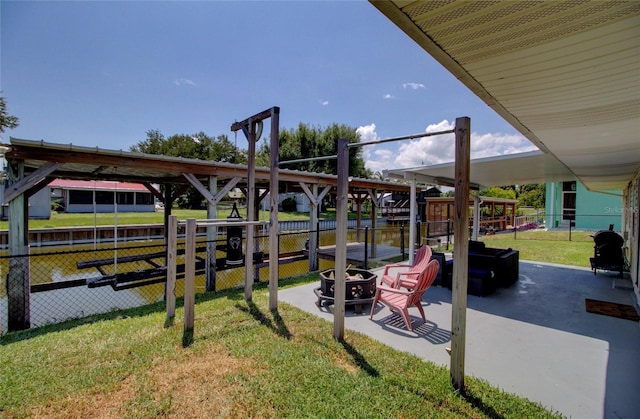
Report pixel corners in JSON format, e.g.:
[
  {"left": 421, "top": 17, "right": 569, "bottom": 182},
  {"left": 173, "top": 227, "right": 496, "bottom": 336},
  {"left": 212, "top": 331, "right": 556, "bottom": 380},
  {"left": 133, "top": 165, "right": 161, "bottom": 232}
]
[{"left": 0, "top": 226, "right": 407, "bottom": 334}]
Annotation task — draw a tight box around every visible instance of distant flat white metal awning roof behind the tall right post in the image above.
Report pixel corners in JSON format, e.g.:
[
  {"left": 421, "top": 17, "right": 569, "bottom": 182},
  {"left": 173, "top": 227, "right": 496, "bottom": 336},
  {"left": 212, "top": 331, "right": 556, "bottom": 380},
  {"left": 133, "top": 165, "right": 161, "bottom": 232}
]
[{"left": 386, "top": 151, "right": 575, "bottom": 189}]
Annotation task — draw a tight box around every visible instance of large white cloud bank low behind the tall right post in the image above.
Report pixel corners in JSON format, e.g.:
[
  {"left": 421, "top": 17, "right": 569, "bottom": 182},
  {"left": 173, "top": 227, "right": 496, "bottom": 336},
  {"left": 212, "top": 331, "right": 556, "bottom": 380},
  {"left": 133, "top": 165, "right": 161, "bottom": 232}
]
[{"left": 356, "top": 120, "right": 537, "bottom": 175}]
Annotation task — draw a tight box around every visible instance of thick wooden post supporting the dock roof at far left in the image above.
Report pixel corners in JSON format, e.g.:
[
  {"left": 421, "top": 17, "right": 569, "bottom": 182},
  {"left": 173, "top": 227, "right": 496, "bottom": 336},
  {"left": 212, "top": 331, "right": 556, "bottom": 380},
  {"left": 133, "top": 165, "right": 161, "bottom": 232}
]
[{"left": 7, "top": 160, "right": 31, "bottom": 332}]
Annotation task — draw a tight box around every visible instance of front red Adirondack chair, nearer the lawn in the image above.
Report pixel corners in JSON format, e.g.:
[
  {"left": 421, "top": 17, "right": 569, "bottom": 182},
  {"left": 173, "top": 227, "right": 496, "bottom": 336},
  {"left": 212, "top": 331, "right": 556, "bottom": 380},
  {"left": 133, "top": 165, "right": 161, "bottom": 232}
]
[{"left": 369, "top": 259, "right": 440, "bottom": 331}]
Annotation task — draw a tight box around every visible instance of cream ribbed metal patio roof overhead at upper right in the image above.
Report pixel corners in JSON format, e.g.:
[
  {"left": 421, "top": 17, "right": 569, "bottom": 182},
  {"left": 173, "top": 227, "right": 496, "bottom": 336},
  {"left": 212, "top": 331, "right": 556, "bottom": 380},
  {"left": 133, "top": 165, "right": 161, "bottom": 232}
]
[{"left": 370, "top": 0, "right": 640, "bottom": 190}]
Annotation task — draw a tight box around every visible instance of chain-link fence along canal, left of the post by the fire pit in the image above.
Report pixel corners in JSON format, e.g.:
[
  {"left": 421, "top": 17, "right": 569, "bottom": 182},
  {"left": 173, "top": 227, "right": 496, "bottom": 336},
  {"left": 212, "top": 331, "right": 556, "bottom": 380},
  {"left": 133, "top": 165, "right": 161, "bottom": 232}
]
[{"left": 0, "top": 229, "right": 360, "bottom": 334}]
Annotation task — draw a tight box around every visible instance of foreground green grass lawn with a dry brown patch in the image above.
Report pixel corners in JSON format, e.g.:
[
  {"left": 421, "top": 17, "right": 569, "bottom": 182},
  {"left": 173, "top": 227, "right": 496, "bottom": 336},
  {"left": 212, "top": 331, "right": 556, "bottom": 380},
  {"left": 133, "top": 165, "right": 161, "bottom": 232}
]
[{"left": 0, "top": 275, "right": 559, "bottom": 418}]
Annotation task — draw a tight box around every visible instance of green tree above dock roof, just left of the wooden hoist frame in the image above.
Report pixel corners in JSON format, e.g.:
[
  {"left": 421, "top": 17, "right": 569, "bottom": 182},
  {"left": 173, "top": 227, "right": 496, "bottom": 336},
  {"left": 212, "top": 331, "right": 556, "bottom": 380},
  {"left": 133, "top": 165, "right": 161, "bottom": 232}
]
[{"left": 130, "top": 130, "right": 242, "bottom": 209}]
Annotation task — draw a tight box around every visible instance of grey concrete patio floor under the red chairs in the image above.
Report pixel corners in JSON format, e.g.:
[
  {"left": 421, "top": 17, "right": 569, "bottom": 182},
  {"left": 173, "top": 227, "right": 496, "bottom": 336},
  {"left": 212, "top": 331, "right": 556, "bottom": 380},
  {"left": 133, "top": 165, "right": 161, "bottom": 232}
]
[{"left": 279, "top": 261, "right": 640, "bottom": 419}]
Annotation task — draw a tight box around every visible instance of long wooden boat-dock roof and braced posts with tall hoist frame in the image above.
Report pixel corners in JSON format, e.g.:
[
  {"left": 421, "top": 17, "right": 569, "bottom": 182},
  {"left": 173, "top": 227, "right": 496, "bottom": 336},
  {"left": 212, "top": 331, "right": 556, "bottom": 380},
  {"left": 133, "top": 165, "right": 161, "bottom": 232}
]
[{"left": 2, "top": 107, "right": 410, "bottom": 331}]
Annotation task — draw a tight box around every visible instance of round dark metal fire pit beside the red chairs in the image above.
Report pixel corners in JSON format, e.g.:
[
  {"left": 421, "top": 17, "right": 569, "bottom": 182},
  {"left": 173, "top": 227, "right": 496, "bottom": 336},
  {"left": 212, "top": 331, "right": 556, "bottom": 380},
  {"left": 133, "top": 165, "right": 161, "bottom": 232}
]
[{"left": 313, "top": 268, "right": 378, "bottom": 314}]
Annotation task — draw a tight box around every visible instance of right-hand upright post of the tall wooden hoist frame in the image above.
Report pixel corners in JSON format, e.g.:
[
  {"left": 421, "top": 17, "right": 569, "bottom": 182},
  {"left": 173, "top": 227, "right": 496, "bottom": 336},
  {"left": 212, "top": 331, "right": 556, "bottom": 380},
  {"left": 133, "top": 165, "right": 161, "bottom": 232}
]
[{"left": 269, "top": 108, "right": 280, "bottom": 310}]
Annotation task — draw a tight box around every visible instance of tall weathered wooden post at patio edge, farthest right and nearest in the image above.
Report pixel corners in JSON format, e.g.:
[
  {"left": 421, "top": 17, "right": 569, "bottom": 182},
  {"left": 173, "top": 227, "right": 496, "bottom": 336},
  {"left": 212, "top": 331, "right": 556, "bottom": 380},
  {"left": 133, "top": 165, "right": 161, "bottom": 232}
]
[{"left": 451, "top": 117, "right": 471, "bottom": 390}]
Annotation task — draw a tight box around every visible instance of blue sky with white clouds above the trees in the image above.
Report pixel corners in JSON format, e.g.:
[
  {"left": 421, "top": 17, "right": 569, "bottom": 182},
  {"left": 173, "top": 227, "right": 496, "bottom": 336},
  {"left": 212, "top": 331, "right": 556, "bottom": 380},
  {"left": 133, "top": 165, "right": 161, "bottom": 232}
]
[{"left": 0, "top": 1, "right": 535, "bottom": 171}]
